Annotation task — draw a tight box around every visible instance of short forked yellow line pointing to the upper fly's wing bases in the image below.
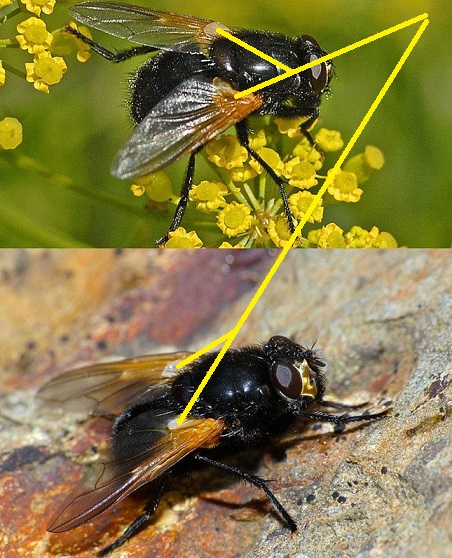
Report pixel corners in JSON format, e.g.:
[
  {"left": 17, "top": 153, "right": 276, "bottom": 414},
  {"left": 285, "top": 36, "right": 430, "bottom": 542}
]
[{"left": 215, "top": 14, "right": 428, "bottom": 99}]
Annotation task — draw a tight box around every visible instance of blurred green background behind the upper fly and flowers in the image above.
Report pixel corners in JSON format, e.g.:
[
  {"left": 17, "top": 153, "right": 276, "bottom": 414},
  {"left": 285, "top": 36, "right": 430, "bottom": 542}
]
[{"left": 0, "top": 0, "right": 452, "bottom": 247}]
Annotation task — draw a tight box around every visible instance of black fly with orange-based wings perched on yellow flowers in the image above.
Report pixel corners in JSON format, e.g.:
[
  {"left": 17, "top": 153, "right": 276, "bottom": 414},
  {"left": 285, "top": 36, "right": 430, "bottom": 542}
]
[{"left": 65, "top": 2, "right": 333, "bottom": 245}]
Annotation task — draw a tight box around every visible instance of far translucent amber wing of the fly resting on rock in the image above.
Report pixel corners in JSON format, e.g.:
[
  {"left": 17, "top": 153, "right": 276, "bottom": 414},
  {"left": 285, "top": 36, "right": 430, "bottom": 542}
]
[{"left": 38, "top": 352, "right": 190, "bottom": 415}]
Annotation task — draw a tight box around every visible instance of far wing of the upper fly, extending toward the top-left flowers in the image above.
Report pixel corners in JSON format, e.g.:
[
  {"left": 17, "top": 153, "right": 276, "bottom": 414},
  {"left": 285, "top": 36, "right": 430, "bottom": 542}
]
[{"left": 69, "top": 2, "right": 227, "bottom": 52}]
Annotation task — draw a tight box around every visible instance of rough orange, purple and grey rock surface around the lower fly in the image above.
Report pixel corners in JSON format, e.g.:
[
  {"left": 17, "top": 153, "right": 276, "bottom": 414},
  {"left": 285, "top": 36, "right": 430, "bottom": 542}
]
[{"left": 0, "top": 250, "right": 452, "bottom": 558}]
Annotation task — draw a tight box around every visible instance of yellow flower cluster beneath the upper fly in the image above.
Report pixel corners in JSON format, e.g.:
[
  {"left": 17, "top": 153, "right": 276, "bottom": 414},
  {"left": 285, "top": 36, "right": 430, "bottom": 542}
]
[{"left": 132, "top": 118, "right": 397, "bottom": 248}]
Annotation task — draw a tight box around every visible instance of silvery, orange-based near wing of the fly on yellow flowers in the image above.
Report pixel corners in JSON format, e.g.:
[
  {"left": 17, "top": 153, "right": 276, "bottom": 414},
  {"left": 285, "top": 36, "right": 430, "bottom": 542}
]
[{"left": 111, "top": 75, "right": 263, "bottom": 179}]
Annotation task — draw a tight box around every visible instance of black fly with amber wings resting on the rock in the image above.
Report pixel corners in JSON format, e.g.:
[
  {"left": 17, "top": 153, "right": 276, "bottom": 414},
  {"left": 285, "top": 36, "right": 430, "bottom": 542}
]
[{"left": 39, "top": 335, "right": 387, "bottom": 555}]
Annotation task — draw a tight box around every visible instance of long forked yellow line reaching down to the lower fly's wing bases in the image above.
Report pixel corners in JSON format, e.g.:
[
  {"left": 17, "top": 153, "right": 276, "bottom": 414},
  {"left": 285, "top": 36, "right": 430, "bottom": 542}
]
[{"left": 177, "top": 14, "right": 429, "bottom": 425}]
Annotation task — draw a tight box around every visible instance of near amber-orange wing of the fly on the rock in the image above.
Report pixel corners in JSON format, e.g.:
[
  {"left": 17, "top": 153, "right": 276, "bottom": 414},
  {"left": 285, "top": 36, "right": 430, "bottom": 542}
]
[{"left": 48, "top": 416, "right": 225, "bottom": 533}]
